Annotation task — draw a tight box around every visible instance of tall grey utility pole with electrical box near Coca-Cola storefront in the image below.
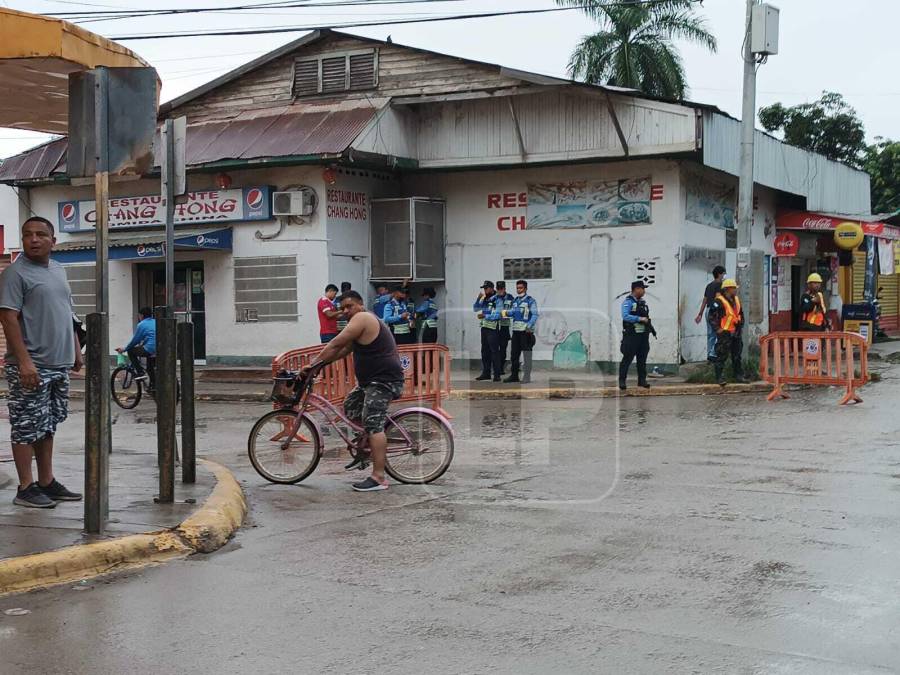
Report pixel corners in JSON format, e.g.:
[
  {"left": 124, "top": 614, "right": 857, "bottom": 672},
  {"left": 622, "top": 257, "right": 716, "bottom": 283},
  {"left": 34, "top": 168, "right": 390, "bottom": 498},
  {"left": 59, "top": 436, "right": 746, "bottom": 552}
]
[{"left": 737, "top": 0, "right": 757, "bottom": 298}]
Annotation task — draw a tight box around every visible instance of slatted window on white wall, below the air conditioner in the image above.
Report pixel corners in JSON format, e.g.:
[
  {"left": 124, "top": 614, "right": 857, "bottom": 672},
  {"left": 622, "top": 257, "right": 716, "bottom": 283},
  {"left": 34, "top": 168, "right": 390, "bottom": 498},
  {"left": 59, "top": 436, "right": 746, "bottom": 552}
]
[{"left": 234, "top": 255, "right": 297, "bottom": 323}]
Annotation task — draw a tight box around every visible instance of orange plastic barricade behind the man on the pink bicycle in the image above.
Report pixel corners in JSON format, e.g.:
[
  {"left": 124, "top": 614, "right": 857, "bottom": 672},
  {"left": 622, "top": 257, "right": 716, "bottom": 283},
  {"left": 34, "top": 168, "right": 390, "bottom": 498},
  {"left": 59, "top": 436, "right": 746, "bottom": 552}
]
[{"left": 272, "top": 344, "right": 450, "bottom": 418}]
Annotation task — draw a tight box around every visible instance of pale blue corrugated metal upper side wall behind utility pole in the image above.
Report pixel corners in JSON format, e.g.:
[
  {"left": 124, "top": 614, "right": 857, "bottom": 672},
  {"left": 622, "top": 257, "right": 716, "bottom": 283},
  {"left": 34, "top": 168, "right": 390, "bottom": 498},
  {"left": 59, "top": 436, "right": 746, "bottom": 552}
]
[{"left": 703, "top": 111, "right": 871, "bottom": 214}]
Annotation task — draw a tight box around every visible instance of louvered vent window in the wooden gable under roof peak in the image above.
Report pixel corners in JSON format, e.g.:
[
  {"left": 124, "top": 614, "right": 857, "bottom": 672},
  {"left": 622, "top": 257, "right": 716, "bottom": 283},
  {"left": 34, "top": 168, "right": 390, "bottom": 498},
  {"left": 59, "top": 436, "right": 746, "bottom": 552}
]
[{"left": 293, "top": 49, "right": 378, "bottom": 97}]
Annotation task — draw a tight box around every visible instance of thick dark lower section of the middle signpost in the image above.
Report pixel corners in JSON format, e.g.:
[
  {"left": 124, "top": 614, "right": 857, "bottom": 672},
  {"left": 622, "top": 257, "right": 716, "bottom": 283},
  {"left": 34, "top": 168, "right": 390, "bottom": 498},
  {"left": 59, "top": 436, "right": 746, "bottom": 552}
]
[{"left": 156, "top": 312, "right": 177, "bottom": 503}]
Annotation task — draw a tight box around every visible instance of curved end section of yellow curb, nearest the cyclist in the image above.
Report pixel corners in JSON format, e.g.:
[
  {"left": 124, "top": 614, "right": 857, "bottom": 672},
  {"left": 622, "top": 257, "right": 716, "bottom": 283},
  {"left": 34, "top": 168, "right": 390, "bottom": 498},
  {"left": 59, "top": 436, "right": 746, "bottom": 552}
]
[{"left": 175, "top": 460, "right": 247, "bottom": 553}]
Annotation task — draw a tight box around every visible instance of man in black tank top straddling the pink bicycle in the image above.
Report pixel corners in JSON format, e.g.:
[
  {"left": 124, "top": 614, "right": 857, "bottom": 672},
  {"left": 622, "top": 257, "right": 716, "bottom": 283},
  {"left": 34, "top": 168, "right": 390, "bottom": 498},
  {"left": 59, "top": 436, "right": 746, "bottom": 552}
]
[{"left": 301, "top": 291, "right": 403, "bottom": 492}]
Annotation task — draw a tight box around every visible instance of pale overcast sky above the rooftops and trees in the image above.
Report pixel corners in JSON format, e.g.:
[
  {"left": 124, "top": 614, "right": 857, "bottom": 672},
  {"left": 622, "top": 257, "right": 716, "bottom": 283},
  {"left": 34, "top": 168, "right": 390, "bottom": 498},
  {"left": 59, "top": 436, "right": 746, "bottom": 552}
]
[{"left": 0, "top": 0, "right": 900, "bottom": 157}]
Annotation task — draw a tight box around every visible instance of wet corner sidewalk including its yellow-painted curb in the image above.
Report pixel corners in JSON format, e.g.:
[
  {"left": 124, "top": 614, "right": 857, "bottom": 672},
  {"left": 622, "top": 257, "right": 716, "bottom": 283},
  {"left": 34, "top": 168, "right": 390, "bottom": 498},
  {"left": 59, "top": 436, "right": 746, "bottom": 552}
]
[{"left": 0, "top": 403, "right": 245, "bottom": 595}]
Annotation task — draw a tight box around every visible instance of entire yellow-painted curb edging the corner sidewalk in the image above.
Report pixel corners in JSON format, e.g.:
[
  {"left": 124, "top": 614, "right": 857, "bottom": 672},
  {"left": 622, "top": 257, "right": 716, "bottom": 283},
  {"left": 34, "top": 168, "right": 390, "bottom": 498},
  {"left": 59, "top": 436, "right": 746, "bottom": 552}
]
[{"left": 0, "top": 460, "right": 247, "bottom": 596}]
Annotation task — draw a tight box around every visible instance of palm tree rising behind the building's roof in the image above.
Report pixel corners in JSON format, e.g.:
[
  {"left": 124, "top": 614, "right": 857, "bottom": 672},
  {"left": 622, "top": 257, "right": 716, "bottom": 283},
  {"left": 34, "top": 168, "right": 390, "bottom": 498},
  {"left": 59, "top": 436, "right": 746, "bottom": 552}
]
[{"left": 556, "top": 0, "right": 717, "bottom": 100}]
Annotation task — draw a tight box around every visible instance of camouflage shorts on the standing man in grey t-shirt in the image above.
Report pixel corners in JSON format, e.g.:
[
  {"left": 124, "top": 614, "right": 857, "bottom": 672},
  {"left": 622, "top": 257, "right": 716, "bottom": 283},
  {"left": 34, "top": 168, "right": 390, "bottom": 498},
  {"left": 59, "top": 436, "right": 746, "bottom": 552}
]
[{"left": 6, "top": 363, "right": 69, "bottom": 445}]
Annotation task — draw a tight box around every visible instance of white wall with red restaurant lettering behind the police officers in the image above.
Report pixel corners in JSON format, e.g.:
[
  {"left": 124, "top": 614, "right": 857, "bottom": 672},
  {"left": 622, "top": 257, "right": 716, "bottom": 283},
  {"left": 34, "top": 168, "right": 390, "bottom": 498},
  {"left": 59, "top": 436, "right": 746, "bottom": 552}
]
[{"left": 404, "top": 161, "right": 682, "bottom": 364}]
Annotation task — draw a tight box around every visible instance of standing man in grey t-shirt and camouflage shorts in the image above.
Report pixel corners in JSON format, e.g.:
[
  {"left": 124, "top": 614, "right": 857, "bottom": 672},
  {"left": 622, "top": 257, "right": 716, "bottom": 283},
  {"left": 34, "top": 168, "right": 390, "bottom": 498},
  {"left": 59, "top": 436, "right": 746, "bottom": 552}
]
[{"left": 0, "top": 217, "right": 82, "bottom": 508}]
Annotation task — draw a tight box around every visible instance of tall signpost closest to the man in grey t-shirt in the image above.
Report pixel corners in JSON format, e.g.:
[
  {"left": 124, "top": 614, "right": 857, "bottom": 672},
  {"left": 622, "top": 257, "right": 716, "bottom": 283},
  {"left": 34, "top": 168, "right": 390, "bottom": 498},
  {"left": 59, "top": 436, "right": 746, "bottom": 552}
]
[{"left": 84, "top": 68, "right": 112, "bottom": 534}]
